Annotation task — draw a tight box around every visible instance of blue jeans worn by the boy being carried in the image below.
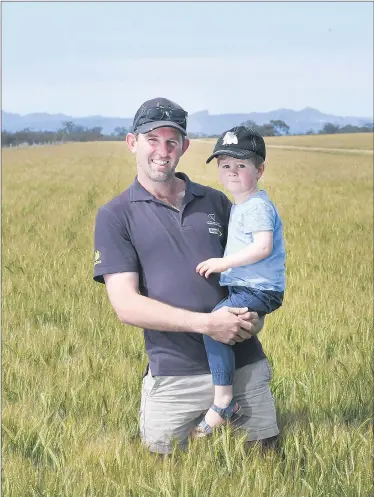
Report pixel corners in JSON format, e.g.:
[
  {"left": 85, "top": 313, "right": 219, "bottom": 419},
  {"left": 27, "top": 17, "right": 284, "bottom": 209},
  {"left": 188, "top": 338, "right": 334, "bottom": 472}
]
[{"left": 203, "top": 286, "right": 283, "bottom": 385}]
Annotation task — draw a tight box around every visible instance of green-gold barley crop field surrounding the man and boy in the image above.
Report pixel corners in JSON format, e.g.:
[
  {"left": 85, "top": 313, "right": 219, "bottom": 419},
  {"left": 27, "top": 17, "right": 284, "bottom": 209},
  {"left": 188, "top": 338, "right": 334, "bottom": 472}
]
[{"left": 2, "top": 135, "right": 374, "bottom": 497}]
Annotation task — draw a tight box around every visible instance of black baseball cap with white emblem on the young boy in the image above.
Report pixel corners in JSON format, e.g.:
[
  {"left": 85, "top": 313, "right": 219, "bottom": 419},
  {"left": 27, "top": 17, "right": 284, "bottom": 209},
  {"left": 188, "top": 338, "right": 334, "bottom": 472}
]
[{"left": 206, "top": 126, "right": 266, "bottom": 164}]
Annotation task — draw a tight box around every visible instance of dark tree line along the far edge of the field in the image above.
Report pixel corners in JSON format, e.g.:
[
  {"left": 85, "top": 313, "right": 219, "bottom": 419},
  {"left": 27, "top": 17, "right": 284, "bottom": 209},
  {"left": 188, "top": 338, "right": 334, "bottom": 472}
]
[{"left": 1, "top": 119, "right": 373, "bottom": 147}]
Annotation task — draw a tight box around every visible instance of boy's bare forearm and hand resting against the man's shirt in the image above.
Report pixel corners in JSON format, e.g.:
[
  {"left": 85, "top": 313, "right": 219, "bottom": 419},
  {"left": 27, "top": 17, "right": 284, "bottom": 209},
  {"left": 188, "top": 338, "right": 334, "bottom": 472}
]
[{"left": 196, "top": 231, "right": 273, "bottom": 278}]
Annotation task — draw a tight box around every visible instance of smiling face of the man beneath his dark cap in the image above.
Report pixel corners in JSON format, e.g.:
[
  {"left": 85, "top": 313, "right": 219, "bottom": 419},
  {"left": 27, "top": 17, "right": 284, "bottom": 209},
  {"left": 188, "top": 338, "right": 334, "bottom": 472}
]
[{"left": 126, "top": 127, "right": 189, "bottom": 182}]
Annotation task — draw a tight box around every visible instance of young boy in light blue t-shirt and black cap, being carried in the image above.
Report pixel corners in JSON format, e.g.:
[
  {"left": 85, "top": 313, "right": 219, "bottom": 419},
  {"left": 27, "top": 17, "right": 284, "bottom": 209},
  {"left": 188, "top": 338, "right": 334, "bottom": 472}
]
[{"left": 194, "top": 126, "right": 285, "bottom": 437}]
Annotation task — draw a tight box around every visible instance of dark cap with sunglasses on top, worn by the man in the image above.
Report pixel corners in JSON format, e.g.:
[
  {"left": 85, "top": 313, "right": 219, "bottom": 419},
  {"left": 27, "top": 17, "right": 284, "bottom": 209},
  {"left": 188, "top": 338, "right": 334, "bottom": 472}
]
[{"left": 133, "top": 97, "right": 188, "bottom": 135}]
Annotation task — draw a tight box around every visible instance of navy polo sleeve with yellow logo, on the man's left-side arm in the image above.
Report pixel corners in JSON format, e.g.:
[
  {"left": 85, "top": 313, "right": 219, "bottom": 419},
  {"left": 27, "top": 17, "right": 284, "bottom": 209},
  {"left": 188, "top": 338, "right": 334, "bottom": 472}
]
[{"left": 93, "top": 207, "right": 139, "bottom": 283}]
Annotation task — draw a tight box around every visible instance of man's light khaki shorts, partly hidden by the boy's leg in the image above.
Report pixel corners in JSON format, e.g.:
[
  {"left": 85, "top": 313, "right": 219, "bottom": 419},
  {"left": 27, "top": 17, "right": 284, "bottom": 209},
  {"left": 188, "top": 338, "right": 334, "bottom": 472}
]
[{"left": 140, "top": 359, "right": 279, "bottom": 454}]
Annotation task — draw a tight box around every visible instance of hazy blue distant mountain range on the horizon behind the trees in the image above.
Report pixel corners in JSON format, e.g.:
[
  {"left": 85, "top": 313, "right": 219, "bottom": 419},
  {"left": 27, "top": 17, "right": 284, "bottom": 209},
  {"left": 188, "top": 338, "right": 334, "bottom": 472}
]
[{"left": 2, "top": 107, "right": 373, "bottom": 135}]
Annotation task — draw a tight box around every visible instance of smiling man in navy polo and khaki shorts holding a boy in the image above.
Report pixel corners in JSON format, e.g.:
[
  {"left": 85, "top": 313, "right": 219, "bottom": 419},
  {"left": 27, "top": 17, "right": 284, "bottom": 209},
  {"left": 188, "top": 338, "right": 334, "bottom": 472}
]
[{"left": 94, "top": 98, "right": 279, "bottom": 454}]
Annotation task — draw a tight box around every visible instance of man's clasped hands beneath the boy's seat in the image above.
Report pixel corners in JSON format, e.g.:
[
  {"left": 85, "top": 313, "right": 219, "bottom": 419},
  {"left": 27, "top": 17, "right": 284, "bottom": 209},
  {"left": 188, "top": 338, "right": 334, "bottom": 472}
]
[{"left": 207, "top": 306, "right": 258, "bottom": 345}]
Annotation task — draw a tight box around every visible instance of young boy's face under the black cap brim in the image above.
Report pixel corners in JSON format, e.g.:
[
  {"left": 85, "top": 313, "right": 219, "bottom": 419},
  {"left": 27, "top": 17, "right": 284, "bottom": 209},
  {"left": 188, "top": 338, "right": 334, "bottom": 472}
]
[{"left": 217, "top": 155, "right": 264, "bottom": 195}]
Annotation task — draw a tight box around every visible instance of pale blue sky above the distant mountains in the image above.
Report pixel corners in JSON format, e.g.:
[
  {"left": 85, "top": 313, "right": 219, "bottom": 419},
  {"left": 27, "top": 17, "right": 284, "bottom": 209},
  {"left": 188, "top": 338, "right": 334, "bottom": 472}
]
[{"left": 2, "top": 2, "right": 373, "bottom": 117}]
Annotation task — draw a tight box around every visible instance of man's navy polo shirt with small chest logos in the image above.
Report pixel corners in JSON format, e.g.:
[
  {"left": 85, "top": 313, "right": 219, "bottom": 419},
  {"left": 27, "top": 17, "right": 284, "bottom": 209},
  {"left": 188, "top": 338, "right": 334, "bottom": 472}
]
[{"left": 94, "top": 173, "right": 265, "bottom": 376}]
